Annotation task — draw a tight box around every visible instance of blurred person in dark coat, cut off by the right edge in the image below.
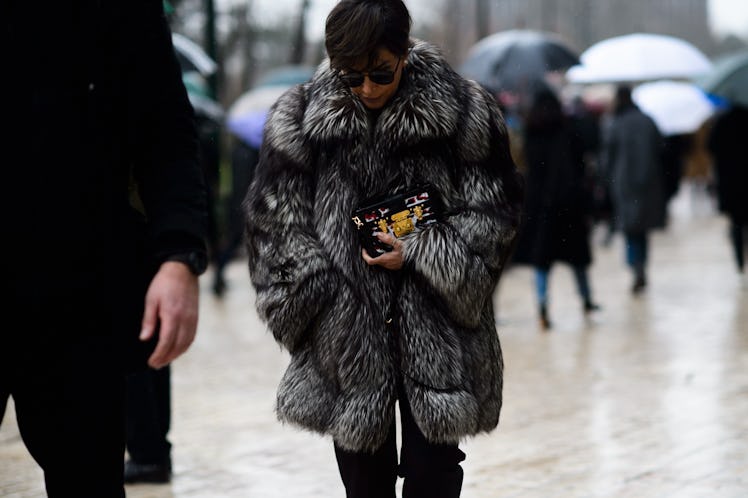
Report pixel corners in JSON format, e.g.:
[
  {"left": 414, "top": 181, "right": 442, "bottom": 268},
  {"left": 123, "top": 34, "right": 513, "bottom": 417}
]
[{"left": 708, "top": 103, "right": 748, "bottom": 273}]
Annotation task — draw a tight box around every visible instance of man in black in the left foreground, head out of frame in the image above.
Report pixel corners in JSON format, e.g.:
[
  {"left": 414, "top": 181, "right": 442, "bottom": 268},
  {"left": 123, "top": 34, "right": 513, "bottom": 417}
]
[{"left": 0, "top": 0, "right": 206, "bottom": 498}]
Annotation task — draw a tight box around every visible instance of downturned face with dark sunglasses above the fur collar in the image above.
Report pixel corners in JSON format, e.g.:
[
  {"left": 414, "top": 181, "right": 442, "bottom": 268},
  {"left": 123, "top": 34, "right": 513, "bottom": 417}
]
[{"left": 341, "top": 48, "right": 406, "bottom": 109}]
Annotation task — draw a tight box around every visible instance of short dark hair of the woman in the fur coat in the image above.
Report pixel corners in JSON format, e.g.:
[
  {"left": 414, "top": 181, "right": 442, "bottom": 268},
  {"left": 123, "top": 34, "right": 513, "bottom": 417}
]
[{"left": 325, "top": 0, "right": 411, "bottom": 69}]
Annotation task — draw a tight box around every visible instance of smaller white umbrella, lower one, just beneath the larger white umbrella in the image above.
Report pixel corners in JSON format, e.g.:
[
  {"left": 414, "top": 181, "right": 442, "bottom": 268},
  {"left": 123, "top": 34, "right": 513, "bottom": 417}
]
[{"left": 631, "top": 80, "right": 715, "bottom": 136}]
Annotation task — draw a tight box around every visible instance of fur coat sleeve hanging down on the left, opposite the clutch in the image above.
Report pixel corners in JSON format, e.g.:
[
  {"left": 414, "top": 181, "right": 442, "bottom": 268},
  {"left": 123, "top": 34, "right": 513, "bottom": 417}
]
[{"left": 244, "top": 87, "right": 337, "bottom": 352}]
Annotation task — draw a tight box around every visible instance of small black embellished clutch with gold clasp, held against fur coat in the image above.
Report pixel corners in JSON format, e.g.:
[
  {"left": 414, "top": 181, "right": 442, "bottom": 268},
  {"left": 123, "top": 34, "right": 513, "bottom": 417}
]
[{"left": 351, "top": 185, "right": 443, "bottom": 257}]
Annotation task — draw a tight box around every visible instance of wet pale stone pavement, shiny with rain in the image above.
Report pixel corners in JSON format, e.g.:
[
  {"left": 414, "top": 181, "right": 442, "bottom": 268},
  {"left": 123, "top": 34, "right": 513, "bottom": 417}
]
[{"left": 0, "top": 185, "right": 748, "bottom": 498}]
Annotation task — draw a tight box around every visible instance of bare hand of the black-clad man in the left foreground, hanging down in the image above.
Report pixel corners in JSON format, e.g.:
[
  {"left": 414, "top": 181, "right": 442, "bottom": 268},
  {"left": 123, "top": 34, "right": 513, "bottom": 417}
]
[{"left": 140, "top": 261, "right": 200, "bottom": 368}]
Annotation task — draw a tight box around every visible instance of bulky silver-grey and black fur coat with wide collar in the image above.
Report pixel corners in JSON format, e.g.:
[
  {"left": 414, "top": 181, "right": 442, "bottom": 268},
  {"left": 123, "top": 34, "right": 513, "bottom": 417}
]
[{"left": 244, "top": 40, "right": 523, "bottom": 451}]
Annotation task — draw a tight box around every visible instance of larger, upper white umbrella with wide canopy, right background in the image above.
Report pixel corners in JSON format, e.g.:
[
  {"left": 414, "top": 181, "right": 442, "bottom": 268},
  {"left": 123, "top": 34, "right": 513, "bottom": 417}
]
[{"left": 566, "top": 33, "right": 712, "bottom": 83}]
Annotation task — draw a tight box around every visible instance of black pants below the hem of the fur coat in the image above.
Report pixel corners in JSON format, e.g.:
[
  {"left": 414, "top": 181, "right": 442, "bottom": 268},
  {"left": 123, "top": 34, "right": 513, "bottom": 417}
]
[{"left": 335, "top": 389, "right": 465, "bottom": 498}]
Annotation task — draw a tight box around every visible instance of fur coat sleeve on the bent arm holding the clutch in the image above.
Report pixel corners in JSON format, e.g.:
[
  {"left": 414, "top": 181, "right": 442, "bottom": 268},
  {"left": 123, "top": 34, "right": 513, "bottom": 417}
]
[{"left": 404, "top": 83, "right": 523, "bottom": 327}]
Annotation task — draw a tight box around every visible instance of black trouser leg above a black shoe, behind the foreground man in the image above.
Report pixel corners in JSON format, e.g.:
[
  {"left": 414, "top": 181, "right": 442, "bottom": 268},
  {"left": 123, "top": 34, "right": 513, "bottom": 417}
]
[{"left": 125, "top": 365, "right": 171, "bottom": 464}]
